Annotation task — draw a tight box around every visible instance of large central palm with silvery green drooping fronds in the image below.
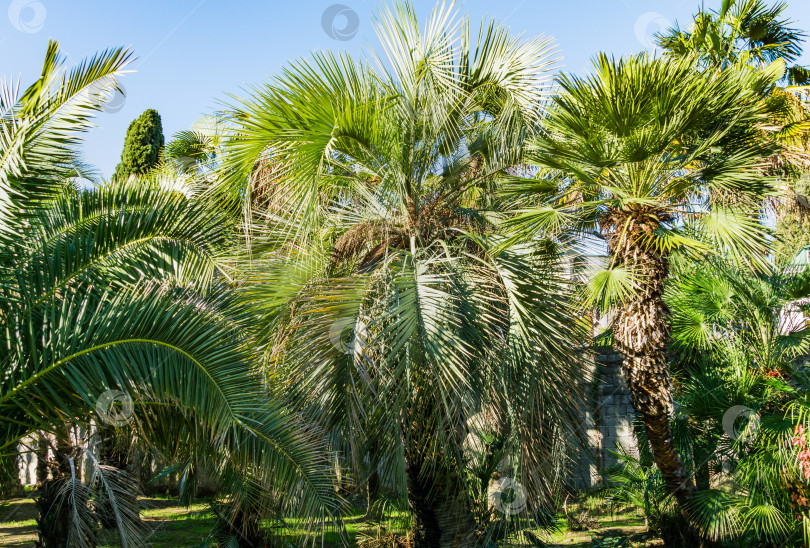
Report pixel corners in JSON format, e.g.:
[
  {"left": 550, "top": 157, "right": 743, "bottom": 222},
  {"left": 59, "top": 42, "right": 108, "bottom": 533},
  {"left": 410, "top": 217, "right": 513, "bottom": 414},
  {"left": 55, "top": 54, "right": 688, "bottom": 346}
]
[{"left": 219, "top": 4, "right": 582, "bottom": 547}]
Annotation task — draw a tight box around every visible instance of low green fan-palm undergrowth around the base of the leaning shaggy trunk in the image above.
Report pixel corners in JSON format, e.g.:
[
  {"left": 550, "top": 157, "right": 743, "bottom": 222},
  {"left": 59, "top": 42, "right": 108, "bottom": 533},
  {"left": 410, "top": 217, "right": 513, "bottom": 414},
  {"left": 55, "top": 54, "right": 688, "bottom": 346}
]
[{"left": 592, "top": 258, "right": 810, "bottom": 546}]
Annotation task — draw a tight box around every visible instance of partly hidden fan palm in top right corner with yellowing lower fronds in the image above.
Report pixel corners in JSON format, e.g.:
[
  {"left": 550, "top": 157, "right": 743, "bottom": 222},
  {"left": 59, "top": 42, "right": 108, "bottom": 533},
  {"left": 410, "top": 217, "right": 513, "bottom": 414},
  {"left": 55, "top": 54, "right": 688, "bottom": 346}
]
[{"left": 658, "top": 0, "right": 810, "bottom": 253}]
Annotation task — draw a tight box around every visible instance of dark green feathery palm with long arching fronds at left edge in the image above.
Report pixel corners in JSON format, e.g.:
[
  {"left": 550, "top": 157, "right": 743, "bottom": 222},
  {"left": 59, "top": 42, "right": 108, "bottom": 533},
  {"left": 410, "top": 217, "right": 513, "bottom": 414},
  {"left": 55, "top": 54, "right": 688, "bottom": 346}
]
[{"left": 0, "top": 42, "right": 335, "bottom": 547}]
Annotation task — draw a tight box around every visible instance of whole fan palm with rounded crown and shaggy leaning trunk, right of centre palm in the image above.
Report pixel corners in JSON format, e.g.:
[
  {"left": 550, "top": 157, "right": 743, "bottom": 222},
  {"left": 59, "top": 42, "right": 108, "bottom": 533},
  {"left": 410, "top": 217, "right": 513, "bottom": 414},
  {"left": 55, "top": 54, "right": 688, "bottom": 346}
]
[{"left": 509, "top": 54, "right": 781, "bottom": 528}]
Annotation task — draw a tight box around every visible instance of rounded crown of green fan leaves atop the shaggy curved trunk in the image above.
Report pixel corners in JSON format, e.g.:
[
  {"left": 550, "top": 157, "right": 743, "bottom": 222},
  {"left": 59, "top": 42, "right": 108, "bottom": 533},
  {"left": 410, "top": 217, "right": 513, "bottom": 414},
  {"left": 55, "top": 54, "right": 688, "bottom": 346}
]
[{"left": 506, "top": 50, "right": 781, "bottom": 268}]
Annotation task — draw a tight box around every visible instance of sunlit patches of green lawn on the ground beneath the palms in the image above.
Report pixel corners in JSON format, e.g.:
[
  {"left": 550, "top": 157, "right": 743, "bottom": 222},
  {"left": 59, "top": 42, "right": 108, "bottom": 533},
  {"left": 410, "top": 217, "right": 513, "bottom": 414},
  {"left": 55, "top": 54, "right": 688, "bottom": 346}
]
[{"left": 0, "top": 498, "right": 662, "bottom": 548}]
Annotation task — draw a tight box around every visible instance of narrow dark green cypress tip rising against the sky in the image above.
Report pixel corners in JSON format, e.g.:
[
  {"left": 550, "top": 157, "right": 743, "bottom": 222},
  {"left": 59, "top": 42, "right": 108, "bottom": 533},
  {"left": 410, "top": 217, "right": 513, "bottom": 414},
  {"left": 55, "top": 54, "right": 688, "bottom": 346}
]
[{"left": 113, "top": 108, "right": 164, "bottom": 181}]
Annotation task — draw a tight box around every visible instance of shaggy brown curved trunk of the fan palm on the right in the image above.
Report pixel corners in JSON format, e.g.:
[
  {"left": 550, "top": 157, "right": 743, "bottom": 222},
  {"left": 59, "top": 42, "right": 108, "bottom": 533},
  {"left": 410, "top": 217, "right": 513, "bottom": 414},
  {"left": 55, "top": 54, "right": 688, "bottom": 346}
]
[{"left": 611, "top": 237, "right": 695, "bottom": 513}]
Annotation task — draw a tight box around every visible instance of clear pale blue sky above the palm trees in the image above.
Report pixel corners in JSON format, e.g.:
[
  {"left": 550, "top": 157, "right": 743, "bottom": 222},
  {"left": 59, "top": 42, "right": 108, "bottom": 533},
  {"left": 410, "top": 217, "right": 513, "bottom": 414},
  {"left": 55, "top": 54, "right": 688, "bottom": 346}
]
[{"left": 0, "top": 0, "right": 810, "bottom": 177}]
